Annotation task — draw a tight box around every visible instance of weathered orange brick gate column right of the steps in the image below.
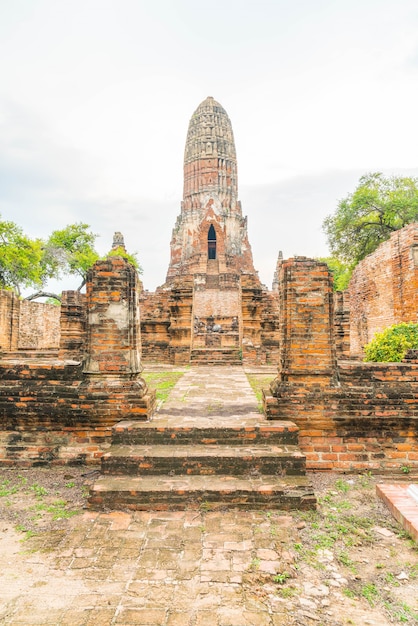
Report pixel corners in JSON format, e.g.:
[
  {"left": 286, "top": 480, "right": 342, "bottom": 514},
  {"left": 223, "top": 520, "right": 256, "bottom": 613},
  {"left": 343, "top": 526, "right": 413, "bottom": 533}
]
[{"left": 265, "top": 257, "right": 337, "bottom": 419}]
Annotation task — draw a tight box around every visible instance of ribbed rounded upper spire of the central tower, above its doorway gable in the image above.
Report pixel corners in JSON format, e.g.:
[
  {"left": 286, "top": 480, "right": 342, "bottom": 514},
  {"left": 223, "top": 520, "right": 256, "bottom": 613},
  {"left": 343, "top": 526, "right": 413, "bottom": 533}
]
[{"left": 183, "top": 96, "right": 238, "bottom": 209}]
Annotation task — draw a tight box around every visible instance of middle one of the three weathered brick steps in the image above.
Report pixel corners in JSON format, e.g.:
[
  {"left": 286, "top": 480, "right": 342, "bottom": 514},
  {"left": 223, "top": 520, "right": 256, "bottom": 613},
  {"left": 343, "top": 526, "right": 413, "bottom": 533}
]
[{"left": 102, "top": 445, "right": 306, "bottom": 476}]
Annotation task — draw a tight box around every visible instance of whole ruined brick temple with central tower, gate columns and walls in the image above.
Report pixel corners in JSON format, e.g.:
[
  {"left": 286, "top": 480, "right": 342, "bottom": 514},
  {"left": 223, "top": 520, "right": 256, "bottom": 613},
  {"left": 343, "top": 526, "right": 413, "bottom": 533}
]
[{"left": 0, "top": 98, "right": 418, "bottom": 498}]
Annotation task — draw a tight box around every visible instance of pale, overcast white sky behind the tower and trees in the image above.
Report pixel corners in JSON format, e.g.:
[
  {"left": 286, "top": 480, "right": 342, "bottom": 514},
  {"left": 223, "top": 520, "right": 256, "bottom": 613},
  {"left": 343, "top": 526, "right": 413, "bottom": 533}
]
[{"left": 0, "top": 0, "right": 418, "bottom": 291}]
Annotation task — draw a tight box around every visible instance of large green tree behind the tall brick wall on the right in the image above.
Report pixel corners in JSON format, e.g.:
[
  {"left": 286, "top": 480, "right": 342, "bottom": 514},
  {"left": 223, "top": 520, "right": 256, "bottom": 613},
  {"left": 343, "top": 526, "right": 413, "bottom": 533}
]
[{"left": 323, "top": 172, "right": 418, "bottom": 268}]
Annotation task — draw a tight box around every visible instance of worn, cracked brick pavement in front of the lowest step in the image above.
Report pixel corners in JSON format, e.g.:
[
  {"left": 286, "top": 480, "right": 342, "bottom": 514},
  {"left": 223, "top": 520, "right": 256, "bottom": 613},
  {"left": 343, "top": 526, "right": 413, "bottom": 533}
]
[{"left": 0, "top": 511, "right": 297, "bottom": 626}]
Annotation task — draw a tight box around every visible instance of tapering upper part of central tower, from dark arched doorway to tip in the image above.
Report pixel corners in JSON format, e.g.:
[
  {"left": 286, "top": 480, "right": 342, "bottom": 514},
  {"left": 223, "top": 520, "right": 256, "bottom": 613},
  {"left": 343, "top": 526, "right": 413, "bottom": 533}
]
[{"left": 167, "top": 97, "right": 255, "bottom": 283}]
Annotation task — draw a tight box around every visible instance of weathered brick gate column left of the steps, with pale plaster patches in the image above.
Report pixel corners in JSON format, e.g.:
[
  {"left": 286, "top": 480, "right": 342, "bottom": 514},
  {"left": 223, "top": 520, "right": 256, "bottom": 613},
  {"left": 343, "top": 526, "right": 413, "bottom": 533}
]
[{"left": 83, "top": 256, "right": 155, "bottom": 421}]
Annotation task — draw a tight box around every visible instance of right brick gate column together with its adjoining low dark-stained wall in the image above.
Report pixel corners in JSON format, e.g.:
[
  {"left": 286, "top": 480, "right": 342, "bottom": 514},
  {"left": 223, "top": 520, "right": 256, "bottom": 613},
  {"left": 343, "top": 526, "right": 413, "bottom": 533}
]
[{"left": 264, "top": 258, "right": 418, "bottom": 473}]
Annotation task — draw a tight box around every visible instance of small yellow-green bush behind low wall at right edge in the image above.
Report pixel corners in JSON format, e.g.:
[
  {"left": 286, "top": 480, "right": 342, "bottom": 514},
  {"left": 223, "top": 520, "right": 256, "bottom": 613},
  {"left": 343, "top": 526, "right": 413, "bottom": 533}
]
[{"left": 364, "top": 322, "right": 418, "bottom": 363}]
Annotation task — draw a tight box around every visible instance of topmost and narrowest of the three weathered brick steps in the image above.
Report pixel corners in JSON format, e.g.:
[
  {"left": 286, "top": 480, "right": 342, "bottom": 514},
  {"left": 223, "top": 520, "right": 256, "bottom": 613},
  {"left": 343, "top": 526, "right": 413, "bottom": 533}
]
[{"left": 112, "top": 415, "right": 299, "bottom": 446}]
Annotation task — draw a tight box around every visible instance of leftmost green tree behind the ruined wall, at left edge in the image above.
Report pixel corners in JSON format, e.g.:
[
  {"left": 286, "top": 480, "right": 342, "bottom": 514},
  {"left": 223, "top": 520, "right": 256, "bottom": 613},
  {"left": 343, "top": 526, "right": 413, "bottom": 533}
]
[{"left": 0, "top": 219, "right": 48, "bottom": 295}]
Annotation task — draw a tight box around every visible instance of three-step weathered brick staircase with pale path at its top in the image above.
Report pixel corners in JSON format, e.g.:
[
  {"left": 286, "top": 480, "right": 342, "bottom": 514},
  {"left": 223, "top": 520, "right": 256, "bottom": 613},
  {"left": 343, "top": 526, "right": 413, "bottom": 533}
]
[{"left": 89, "top": 367, "right": 316, "bottom": 510}]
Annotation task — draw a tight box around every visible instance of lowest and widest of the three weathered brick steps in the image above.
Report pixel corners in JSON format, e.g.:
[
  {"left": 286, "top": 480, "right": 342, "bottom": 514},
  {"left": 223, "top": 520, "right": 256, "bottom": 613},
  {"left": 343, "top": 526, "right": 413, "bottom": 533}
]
[{"left": 89, "top": 475, "right": 316, "bottom": 511}]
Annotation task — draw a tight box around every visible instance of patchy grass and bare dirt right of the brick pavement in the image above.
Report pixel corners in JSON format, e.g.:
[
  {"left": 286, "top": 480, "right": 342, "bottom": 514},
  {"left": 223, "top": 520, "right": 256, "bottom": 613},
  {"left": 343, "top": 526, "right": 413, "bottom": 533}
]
[{"left": 290, "top": 473, "right": 418, "bottom": 626}]
